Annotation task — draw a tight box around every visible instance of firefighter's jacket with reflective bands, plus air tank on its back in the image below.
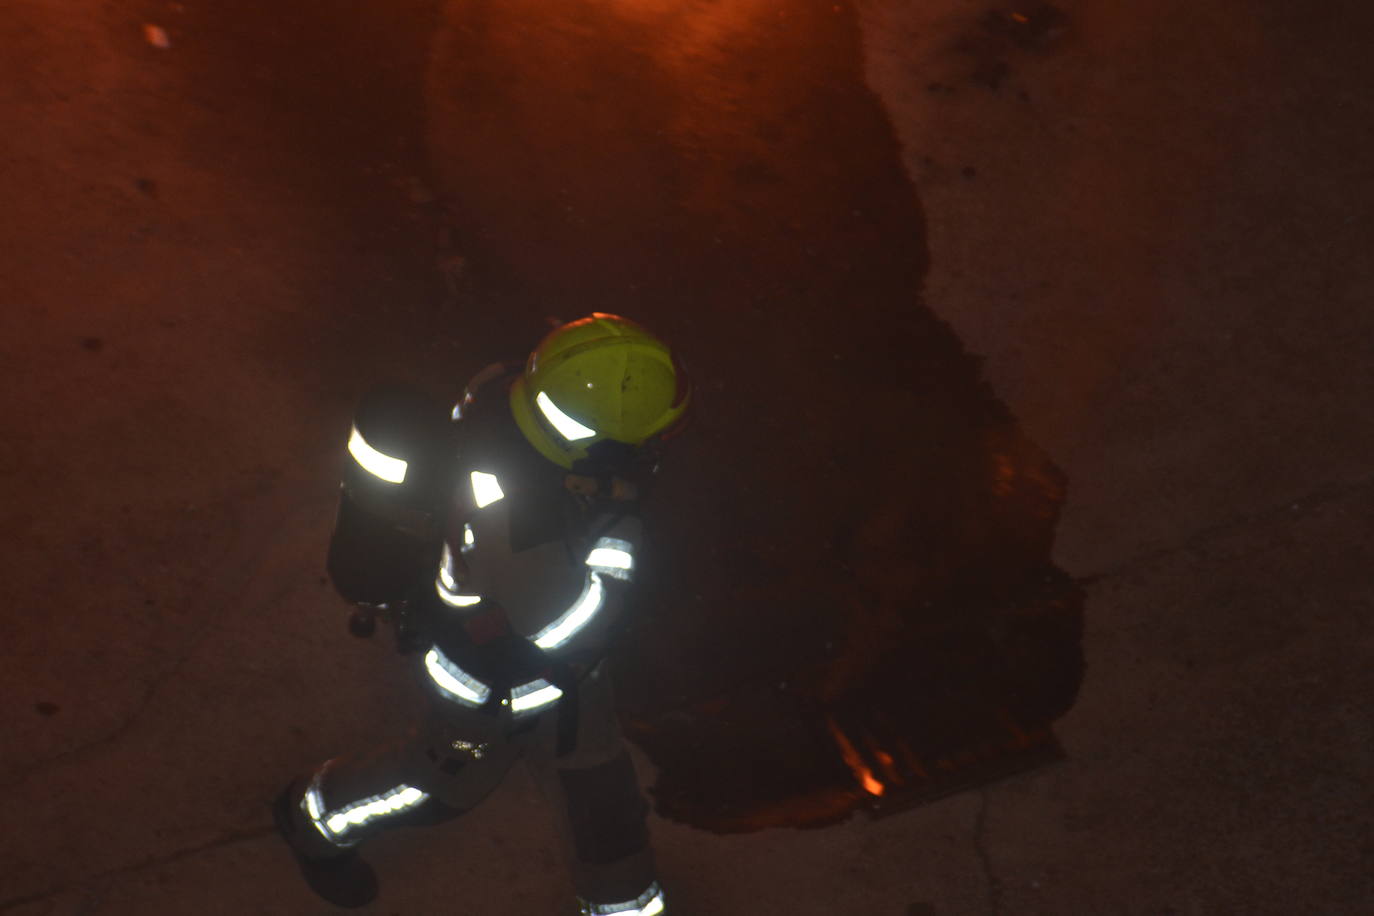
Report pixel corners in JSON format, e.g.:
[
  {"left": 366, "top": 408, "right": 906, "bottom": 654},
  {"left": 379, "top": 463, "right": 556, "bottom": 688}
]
[{"left": 328, "top": 364, "right": 642, "bottom": 744}]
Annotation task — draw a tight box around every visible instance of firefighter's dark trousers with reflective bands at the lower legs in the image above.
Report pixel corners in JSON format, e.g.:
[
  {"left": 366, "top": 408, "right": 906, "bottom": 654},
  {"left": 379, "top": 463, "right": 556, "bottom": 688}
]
[{"left": 287, "top": 665, "right": 664, "bottom": 916}]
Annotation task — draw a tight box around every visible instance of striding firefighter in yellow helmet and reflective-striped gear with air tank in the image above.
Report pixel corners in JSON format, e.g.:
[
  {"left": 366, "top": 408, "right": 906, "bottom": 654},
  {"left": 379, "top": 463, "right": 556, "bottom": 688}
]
[{"left": 273, "top": 313, "right": 690, "bottom": 916}]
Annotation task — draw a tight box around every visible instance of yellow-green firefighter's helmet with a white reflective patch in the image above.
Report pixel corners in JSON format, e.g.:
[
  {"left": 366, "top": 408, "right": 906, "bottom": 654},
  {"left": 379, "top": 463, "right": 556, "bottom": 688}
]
[{"left": 510, "top": 312, "right": 691, "bottom": 470}]
